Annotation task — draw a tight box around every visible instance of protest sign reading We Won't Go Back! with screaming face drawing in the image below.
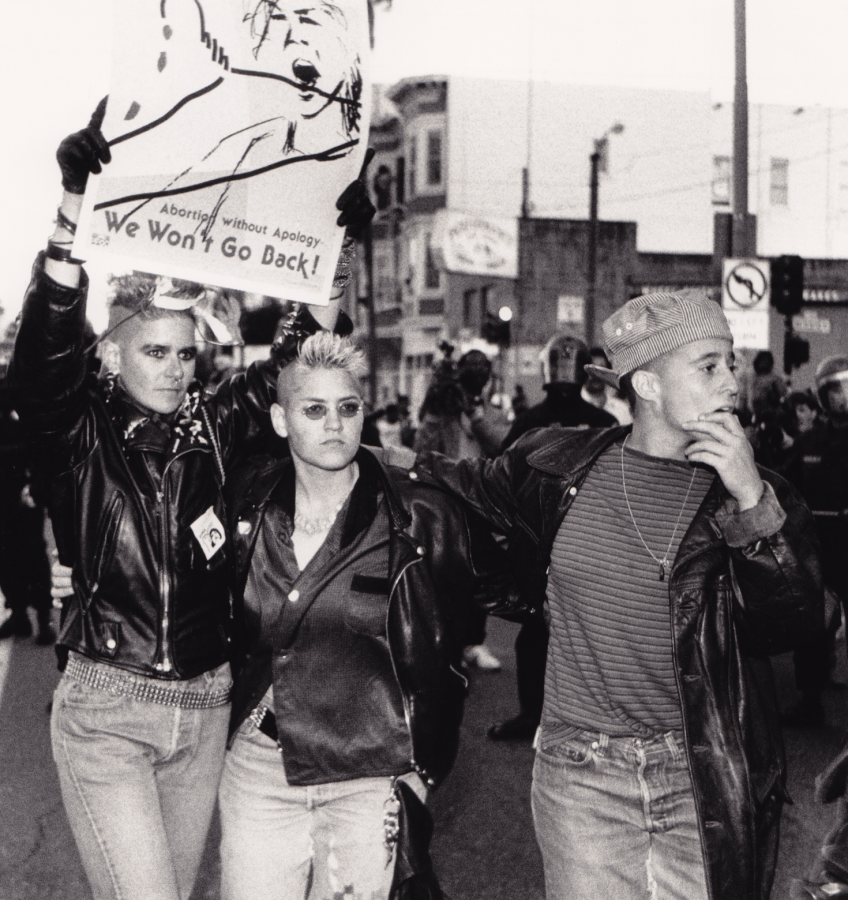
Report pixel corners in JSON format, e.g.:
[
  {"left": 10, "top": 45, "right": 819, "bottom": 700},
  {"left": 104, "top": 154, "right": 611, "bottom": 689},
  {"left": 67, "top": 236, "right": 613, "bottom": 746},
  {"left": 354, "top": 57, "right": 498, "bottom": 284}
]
[{"left": 74, "top": 0, "right": 370, "bottom": 304}]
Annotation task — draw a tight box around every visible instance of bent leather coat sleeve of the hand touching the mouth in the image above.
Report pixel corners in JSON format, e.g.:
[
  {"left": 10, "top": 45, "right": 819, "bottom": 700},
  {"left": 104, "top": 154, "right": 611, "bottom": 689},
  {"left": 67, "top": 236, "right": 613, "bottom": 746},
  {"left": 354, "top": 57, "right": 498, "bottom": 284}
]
[{"left": 717, "top": 472, "right": 824, "bottom": 654}]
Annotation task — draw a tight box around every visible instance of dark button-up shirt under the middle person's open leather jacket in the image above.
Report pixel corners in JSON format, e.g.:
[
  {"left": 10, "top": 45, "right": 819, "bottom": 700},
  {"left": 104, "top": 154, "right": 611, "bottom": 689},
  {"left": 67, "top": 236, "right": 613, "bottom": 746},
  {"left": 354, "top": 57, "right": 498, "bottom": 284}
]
[{"left": 245, "top": 460, "right": 412, "bottom": 784}]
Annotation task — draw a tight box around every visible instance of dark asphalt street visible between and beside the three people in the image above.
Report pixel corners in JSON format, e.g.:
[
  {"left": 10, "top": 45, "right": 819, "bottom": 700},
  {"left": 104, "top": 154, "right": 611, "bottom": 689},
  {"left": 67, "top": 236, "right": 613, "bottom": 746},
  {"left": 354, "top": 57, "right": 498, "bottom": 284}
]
[{"left": 0, "top": 620, "right": 848, "bottom": 900}]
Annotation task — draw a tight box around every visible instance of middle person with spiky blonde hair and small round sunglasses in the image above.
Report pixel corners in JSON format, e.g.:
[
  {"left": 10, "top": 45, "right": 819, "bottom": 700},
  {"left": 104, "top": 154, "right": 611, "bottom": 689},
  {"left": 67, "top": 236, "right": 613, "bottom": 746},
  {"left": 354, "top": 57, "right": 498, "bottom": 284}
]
[{"left": 219, "top": 332, "right": 508, "bottom": 900}]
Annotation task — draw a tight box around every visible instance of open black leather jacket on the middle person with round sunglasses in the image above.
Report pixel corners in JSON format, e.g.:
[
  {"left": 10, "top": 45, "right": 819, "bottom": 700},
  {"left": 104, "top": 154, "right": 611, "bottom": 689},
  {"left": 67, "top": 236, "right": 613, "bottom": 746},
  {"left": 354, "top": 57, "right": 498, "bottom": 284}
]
[{"left": 227, "top": 447, "right": 514, "bottom": 787}]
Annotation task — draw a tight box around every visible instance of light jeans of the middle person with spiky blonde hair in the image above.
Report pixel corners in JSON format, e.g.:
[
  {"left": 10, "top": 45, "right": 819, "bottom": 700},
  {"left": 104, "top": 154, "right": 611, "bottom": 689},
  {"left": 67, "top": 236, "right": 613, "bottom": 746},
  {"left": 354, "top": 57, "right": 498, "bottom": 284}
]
[{"left": 219, "top": 719, "right": 425, "bottom": 900}]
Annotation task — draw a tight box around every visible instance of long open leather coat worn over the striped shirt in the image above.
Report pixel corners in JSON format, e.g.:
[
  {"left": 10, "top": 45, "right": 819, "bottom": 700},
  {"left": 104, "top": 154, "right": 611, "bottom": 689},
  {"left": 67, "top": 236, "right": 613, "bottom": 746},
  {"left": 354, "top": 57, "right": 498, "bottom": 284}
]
[{"left": 412, "top": 428, "right": 823, "bottom": 900}]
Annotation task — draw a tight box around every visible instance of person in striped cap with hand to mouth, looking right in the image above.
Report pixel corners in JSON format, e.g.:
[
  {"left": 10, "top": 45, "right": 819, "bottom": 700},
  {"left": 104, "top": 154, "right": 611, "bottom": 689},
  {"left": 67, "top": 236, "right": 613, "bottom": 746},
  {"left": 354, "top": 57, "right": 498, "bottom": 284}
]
[{"left": 410, "top": 293, "right": 823, "bottom": 900}]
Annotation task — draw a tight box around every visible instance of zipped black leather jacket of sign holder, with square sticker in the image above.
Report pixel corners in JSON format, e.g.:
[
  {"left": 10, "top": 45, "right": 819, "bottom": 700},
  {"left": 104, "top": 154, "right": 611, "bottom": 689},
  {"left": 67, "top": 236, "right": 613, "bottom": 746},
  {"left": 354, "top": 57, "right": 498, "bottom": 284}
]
[{"left": 10, "top": 256, "right": 270, "bottom": 679}]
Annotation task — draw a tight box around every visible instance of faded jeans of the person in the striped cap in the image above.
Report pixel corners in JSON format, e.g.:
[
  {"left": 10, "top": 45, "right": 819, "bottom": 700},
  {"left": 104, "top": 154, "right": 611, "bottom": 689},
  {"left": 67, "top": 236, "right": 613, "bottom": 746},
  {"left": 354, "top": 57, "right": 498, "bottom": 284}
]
[{"left": 532, "top": 732, "right": 707, "bottom": 900}]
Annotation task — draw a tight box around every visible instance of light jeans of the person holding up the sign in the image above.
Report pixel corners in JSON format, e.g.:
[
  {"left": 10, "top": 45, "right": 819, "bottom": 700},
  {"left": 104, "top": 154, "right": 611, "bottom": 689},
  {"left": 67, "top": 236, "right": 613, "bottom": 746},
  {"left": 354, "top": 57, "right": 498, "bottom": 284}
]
[{"left": 51, "top": 665, "right": 232, "bottom": 900}]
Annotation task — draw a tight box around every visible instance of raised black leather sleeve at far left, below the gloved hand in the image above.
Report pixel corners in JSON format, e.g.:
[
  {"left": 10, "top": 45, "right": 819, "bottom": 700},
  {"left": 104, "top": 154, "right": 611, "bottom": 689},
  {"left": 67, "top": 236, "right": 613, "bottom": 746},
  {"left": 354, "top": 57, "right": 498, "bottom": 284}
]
[{"left": 9, "top": 253, "right": 88, "bottom": 437}]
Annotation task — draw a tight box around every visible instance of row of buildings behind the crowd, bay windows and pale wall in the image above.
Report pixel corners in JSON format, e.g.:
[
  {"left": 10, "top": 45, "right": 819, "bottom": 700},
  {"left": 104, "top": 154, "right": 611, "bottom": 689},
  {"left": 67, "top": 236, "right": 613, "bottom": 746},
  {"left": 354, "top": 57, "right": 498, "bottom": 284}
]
[{"left": 354, "top": 76, "right": 848, "bottom": 411}]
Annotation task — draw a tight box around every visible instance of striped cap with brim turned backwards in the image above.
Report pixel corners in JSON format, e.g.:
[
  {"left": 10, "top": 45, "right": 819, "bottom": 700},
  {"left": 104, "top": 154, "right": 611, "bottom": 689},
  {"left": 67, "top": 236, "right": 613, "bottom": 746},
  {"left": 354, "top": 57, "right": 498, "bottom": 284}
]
[{"left": 587, "top": 294, "right": 733, "bottom": 387}]
